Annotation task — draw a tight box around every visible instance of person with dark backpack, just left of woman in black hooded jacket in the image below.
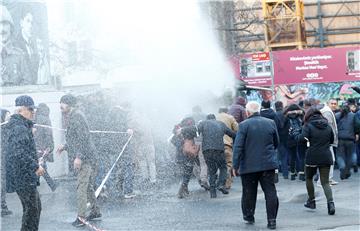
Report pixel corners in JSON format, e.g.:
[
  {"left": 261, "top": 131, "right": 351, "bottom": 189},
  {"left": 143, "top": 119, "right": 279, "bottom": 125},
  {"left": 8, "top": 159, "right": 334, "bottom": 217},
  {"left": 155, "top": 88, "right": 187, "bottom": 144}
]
[{"left": 284, "top": 104, "right": 305, "bottom": 181}]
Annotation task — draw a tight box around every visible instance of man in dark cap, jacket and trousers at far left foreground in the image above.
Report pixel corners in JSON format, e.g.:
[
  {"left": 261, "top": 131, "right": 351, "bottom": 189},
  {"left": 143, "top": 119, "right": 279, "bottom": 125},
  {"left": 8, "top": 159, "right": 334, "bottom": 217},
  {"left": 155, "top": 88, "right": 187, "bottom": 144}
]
[{"left": 2, "top": 95, "right": 44, "bottom": 231}]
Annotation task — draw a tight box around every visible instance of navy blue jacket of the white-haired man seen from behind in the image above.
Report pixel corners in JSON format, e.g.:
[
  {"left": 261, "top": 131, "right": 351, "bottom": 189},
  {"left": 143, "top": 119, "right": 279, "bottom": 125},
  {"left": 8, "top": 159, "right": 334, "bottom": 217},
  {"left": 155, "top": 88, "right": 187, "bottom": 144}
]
[{"left": 233, "top": 113, "right": 279, "bottom": 174}]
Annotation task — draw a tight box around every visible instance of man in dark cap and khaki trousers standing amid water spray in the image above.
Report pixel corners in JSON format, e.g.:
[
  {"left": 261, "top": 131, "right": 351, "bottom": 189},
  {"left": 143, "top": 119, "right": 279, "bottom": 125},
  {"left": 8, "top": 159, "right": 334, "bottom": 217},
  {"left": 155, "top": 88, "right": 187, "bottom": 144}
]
[{"left": 57, "top": 94, "right": 101, "bottom": 227}]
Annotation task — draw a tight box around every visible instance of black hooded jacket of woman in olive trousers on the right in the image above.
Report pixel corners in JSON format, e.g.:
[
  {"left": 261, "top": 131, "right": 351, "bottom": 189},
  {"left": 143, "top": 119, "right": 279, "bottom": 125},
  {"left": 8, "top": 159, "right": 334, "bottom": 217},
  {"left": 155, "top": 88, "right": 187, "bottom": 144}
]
[{"left": 297, "top": 115, "right": 334, "bottom": 166}]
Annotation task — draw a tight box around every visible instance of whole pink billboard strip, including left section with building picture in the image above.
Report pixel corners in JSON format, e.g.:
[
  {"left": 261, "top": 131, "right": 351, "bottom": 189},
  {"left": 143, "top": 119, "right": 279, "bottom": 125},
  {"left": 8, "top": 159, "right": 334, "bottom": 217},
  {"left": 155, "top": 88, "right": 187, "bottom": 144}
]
[{"left": 236, "top": 46, "right": 360, "bottom": 86}]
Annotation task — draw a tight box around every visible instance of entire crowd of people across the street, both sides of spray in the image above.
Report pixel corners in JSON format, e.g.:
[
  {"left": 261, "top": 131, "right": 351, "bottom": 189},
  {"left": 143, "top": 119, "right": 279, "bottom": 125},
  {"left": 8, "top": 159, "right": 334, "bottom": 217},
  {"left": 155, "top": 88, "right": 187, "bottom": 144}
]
[{"left": 1, "top": 90, "right": 360, "bottom": 230}]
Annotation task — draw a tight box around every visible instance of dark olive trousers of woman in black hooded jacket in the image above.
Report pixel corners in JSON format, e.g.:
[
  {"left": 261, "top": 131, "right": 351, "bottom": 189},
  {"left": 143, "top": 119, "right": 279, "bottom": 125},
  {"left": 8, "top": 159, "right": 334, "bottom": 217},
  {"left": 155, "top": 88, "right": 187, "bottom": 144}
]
[{"left": 305, "top": 165, "right": 333, "bottom": 202}]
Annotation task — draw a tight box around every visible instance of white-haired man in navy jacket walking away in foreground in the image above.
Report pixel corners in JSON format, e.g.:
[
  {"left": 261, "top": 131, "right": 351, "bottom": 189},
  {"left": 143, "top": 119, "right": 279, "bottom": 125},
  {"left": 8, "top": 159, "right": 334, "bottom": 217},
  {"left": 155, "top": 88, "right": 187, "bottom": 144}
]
[{"left": 233, "top": 101, "right": 279, "bottom": 229}]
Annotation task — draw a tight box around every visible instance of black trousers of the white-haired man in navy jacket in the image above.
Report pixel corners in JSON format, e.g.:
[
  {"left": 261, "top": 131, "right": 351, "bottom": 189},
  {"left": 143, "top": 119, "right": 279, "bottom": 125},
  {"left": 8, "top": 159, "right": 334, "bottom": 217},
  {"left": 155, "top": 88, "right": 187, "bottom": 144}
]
[{"left": 241, "top": 170, "right": 279, "bottom": 220}]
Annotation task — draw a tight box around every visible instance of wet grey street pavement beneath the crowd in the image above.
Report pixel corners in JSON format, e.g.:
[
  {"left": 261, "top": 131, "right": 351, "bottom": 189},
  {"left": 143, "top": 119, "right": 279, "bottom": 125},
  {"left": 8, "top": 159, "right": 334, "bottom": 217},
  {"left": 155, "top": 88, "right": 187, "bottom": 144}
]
[{"left": 1, "top": 171, "right": 360, "bottom": 231}]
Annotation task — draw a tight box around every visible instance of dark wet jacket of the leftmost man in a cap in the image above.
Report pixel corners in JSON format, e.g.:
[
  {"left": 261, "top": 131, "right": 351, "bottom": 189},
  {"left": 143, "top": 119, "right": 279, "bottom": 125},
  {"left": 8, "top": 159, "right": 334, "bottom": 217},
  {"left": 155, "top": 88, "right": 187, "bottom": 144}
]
[{"left": 1, "top": 114, "right": 39, "bottom": 193}]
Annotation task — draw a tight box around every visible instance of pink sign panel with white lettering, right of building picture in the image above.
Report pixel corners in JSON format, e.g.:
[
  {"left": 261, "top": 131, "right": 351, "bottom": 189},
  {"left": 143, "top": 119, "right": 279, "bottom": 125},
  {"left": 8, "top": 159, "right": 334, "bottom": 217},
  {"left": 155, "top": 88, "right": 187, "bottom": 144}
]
[{"left": 274, "top": 47, "right": 360, "bottom": 84}]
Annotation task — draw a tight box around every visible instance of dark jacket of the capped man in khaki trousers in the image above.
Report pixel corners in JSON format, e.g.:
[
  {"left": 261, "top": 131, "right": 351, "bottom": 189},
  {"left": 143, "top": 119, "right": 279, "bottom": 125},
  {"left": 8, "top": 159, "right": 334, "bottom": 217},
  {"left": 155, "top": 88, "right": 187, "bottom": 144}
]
[{"left": 65, "top": 110, "right": 97, "bottom": 163}]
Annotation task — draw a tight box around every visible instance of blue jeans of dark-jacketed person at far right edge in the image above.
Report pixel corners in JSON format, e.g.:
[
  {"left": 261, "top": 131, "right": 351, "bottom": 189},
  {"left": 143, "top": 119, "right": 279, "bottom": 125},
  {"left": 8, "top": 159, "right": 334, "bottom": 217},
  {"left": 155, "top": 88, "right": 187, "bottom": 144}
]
[{"left": 336, "top": 140, "right": 355, "bottom": 170}]
